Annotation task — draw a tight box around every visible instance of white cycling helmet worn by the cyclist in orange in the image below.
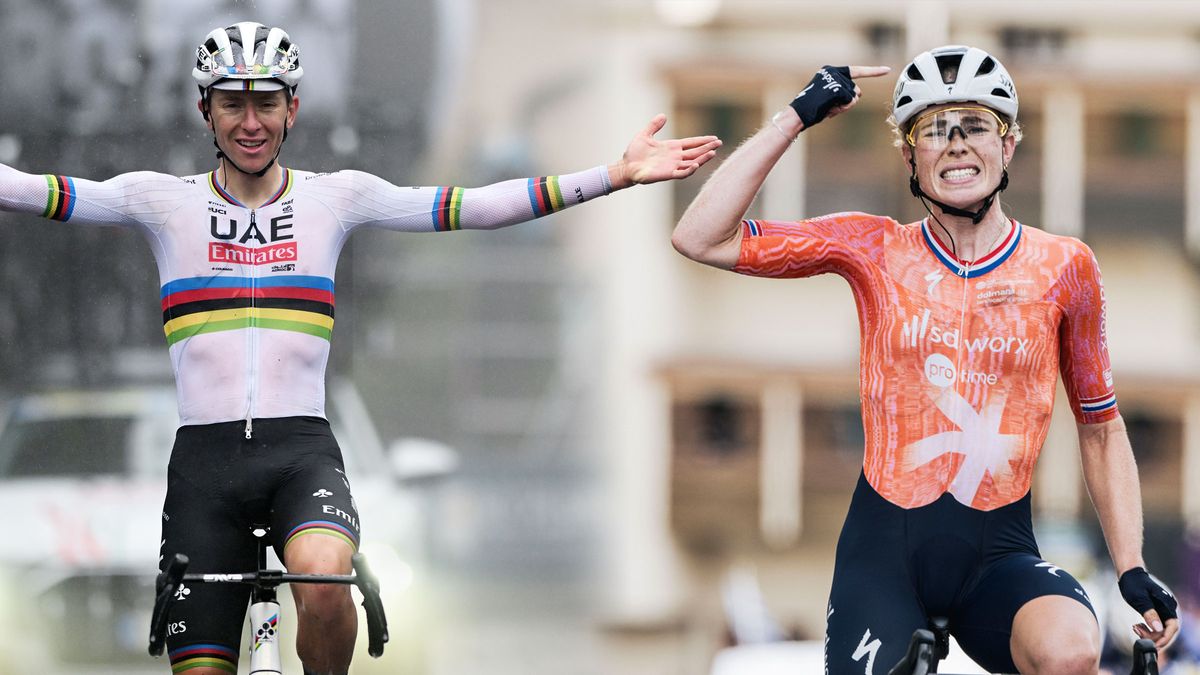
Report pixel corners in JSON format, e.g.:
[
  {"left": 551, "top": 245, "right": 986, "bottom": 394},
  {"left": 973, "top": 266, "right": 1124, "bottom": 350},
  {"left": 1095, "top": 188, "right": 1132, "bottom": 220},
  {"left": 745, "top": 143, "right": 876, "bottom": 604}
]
[{"left": 892, "top": 44, "right": 1016, "bottom": 129}]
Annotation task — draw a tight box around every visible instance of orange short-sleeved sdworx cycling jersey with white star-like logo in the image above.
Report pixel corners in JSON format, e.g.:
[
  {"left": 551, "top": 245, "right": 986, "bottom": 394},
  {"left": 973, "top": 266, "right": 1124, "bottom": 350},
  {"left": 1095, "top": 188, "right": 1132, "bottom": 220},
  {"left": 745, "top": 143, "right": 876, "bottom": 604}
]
[{"left": 734, "top": 213, "right": 1117, "bottom": 510}]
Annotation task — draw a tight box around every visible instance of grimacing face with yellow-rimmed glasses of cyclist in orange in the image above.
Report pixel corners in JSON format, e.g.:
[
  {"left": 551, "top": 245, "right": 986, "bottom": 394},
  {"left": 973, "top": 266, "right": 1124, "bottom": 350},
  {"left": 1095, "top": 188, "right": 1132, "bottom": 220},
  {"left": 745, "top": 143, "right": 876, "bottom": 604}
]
[{"left": 901, "top": 103, "right": 1016, "bottom": 209}]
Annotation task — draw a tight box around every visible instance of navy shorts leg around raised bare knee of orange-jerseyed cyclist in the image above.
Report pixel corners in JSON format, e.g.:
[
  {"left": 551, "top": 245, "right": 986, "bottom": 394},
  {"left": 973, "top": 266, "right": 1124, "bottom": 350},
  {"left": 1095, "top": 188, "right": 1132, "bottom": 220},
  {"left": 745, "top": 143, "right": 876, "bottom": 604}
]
[{"left": 952, "top": 554, "right": 1096, "bottom": 673}]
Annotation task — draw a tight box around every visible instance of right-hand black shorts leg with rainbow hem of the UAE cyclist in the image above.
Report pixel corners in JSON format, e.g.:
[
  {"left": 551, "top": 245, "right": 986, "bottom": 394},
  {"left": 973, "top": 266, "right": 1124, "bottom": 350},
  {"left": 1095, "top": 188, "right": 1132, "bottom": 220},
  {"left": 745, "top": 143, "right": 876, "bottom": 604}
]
[{"left": 271, "top": 418, "right": 359, "bottom": 559}]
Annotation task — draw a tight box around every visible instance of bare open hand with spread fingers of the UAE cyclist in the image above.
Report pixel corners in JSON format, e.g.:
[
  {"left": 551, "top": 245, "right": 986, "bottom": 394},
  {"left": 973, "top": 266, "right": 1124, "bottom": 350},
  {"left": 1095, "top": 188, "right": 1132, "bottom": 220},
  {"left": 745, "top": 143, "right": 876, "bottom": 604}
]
[{"left": 610, "top": 114, "right": 721, "bottom": 190}]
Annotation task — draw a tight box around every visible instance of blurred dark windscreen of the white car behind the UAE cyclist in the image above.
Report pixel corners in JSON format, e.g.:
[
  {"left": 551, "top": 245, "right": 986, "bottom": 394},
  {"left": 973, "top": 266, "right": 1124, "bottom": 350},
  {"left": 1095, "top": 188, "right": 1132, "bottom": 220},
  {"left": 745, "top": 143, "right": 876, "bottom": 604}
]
[{"left": 0, "top": 417, "right": 133, "bottom": 478}]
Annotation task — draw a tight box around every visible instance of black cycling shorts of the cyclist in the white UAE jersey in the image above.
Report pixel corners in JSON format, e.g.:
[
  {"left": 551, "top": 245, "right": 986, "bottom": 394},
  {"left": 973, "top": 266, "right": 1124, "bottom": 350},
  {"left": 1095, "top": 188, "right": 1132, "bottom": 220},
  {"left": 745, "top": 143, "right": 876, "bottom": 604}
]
[{"left": 160, "top": 417, "right": 359, "bottom": 671}]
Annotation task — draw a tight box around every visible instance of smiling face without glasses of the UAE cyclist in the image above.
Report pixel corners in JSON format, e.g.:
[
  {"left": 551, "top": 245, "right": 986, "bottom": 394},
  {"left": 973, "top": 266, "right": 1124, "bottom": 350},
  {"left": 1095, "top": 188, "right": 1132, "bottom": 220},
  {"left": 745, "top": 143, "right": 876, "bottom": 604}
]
[{"left": 200, "top": 89, "right": 300, "bottom": 172}]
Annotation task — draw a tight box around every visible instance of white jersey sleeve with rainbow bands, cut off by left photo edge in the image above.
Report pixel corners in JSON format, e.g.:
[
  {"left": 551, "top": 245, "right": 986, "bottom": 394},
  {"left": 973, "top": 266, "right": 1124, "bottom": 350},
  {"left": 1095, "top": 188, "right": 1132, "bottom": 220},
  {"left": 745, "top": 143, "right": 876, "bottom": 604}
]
[{"left": 0, "top": 165, "right": 188, "bottom": 232}]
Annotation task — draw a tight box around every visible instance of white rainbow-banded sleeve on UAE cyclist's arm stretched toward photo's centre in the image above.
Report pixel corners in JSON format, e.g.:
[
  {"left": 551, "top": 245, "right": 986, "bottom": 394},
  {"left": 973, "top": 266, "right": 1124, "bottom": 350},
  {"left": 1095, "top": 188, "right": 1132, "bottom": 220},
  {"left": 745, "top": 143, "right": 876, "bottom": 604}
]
[{"left": 297, "top": 166, "right": 612, "bottom": 232}]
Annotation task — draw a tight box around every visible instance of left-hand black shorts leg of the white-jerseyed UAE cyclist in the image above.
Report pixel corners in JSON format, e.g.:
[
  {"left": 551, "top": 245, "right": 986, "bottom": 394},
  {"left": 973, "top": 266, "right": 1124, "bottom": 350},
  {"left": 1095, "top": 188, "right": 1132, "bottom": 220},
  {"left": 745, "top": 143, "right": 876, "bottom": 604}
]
[{"left": 160, "top": 430, "right": 257, "bottom": 671}]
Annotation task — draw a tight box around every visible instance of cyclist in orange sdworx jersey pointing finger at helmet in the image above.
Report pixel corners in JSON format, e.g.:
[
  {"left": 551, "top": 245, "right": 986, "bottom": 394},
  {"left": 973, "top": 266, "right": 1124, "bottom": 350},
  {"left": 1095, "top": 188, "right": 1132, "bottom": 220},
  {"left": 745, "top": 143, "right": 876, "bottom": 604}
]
[{"left": 673, "top": 46, "right": 1178, "bottom": 675}]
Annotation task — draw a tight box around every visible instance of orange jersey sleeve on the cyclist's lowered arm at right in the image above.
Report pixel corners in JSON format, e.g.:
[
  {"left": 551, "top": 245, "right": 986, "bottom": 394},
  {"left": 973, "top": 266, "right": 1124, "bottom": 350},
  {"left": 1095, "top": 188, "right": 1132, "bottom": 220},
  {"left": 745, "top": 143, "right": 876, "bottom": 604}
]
[{"left": 1054, "top": 244, "right": 1118, "bottom": 424}]
